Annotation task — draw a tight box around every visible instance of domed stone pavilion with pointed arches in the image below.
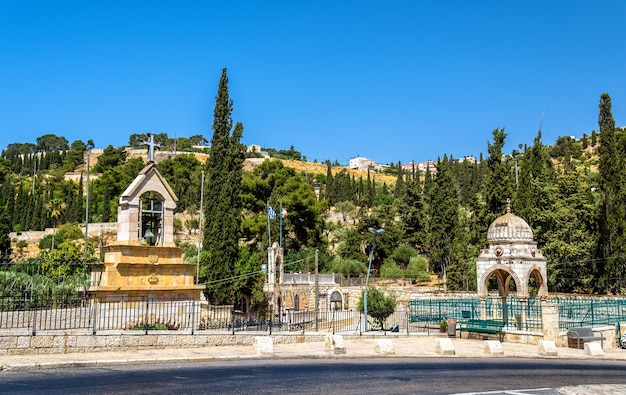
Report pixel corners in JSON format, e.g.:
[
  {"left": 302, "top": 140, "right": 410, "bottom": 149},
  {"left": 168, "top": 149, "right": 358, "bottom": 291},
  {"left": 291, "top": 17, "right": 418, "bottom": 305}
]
[{"left": 476, "top": 204, "right": 548, "bottom": 330}]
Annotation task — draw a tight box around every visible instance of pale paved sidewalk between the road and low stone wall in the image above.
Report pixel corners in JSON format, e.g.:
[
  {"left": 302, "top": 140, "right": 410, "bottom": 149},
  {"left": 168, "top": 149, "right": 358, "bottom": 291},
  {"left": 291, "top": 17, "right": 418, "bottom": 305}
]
[{"left": 0, "top": 336, "right": 626, "bottom": 371}]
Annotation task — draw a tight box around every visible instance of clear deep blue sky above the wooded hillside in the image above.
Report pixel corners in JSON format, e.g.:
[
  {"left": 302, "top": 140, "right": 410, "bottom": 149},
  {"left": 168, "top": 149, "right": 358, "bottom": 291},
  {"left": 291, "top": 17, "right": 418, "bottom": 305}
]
[{"left": 0, "top": 0, "right": 626, "bottom": 164}]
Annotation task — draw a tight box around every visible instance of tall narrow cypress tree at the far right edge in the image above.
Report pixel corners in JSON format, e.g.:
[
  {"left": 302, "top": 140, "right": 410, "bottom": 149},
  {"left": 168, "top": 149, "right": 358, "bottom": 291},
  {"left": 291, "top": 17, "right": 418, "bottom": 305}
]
[{"left": 596, "top": 93, "right": 626, "bottom": 293}]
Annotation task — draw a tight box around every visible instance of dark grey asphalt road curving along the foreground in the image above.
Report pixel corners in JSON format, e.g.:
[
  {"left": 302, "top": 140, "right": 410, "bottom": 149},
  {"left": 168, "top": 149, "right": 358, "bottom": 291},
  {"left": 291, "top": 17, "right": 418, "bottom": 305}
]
[{"left": 0, "top": 358, "right": 626, "bottom": 395}]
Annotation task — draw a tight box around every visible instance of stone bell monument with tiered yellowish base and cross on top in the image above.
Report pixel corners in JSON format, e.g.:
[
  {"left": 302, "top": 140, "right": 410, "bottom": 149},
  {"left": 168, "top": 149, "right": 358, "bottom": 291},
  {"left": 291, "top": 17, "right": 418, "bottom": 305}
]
[{"left": 89, "top": 135, "right": 204, "bottom": 300}]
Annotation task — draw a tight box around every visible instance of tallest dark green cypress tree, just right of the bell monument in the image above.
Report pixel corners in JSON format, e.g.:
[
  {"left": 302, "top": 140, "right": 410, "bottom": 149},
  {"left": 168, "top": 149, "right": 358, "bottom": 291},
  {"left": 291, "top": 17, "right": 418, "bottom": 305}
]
[{"left": 201, "top": 69, "right": 244, "bottom": 304}]
